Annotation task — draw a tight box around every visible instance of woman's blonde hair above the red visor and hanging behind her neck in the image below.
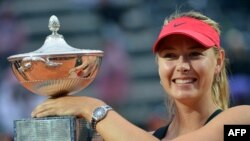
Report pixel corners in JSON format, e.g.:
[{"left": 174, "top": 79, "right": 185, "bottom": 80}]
[{"left": 159, "top": 11, "right": 229, "bottom": 116}]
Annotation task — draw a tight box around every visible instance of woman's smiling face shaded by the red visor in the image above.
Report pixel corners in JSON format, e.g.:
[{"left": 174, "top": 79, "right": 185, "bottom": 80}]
[{"left": 157, "top": 35, "right": 223, "bottom": 101}]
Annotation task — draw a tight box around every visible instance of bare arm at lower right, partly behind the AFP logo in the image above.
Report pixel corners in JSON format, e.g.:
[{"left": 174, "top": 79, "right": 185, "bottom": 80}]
[{"left": 173, "top": 105, "right": 250, "bottom": 141}]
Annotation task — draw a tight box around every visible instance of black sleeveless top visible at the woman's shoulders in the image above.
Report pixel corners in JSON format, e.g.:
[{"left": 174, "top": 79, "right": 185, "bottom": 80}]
[{"left": 153, "top": 109, "right": 222, "bottom": 139}]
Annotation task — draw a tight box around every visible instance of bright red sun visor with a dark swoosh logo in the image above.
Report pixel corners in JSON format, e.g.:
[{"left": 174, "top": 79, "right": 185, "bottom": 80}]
[{"left": 153, "top": 17, "right": 220, "bottom": 53}]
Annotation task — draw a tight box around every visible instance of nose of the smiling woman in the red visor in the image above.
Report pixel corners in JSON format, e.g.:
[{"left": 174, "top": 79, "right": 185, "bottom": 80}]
[{"left": 176, "top": 56, "right": 190, "bottom": 73}]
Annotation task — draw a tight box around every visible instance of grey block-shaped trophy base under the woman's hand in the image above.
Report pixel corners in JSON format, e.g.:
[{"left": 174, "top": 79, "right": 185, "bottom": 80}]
[{"left": 14, "top": 116, "right": 93, "bottom": 141}]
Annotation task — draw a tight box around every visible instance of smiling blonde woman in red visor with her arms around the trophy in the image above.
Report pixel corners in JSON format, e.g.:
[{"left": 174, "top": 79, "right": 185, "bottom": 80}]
[{"left": 32, "top": 12, "right": 250, "bottom": 141}]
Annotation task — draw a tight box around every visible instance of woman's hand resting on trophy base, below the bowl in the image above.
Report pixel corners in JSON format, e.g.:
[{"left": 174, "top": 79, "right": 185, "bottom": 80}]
[{"left": 31, "top": 96, "right": 105, "bottom": 121}]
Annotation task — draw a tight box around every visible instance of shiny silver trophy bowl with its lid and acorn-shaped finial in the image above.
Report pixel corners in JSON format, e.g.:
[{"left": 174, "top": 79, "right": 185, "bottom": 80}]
[{"left": 8, "top": 15, "right": 103, "bottom": 97}]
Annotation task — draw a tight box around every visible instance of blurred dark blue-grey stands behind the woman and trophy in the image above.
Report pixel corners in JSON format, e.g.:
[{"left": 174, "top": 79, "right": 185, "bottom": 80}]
[{"left": 0, "top": 0, "right": 250, "bottom": 141}]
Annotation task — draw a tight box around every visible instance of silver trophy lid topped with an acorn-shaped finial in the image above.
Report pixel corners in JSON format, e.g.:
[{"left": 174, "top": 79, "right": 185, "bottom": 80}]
[{"left": 8, "top": 15, "right": 103, "bottom": 61}]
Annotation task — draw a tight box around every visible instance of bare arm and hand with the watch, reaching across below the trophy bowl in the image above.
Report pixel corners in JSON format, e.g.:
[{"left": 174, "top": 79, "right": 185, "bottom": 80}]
[{"left": 32, "top": 96, "right": 158, "bottom": 141}]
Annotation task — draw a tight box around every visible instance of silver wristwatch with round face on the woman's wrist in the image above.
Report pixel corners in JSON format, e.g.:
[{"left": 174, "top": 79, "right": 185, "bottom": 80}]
[{"left": 91, "top": 105, "right": 112, "bottom": 130}]
